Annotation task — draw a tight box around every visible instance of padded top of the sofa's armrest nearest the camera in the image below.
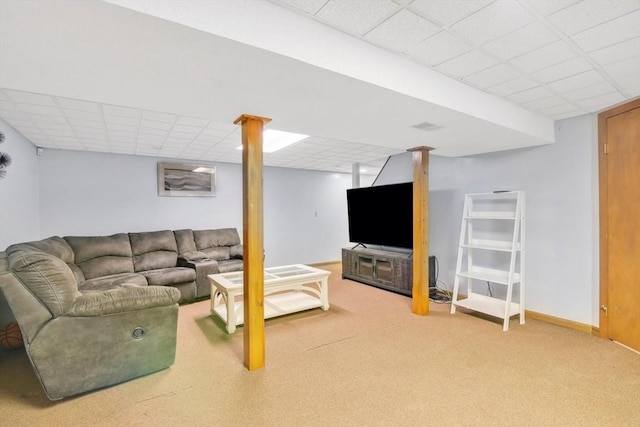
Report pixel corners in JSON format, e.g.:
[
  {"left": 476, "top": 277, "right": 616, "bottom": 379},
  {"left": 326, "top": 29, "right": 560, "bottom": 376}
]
[{"left": 64, "top": 286, "right": 180, "bottom": 317}]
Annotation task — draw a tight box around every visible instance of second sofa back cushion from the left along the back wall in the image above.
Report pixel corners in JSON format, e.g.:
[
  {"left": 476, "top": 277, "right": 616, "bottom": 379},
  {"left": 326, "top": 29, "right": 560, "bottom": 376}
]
[{"left": 129, "top": 230, "right": 178, "bottom": 272}]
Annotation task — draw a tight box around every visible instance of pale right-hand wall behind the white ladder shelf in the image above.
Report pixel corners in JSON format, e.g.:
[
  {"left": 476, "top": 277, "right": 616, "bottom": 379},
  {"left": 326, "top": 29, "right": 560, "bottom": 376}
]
[{"left": 378, "top": 114, "right": 599, "bottom": 326}]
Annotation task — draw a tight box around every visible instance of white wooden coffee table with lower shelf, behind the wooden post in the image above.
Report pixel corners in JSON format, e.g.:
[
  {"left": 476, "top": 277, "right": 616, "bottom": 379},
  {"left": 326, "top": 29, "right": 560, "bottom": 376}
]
[{"left": 208, "top": 264, "right": 331, "bottom": 334}]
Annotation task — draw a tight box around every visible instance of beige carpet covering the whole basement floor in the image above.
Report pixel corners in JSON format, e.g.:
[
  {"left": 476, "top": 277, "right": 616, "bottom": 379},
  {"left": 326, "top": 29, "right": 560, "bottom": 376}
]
[{"left": 0, "top": 264, "right": 640, "bottom": 427}]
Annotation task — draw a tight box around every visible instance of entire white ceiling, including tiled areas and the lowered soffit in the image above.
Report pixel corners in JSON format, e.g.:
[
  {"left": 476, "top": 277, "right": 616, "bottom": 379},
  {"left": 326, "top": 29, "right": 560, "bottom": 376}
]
[{"left": 0, "top": 0, "right": 640, "bottom": 172}]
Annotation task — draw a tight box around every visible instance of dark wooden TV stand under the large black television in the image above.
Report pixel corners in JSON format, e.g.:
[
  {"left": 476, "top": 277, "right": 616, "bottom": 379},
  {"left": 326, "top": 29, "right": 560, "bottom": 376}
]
[{"left": 342, "top": 247, "right": 413, "bottom": 296}]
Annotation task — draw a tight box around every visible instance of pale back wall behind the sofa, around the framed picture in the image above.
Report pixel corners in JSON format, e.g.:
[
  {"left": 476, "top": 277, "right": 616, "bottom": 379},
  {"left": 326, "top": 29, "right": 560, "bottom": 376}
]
[{"left": 40, "top": 150, "right": 351, "bottom": 266}]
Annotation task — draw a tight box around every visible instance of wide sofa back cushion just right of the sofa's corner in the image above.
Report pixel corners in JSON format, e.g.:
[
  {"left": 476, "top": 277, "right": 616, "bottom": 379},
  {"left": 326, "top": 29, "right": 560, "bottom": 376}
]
[{"left": 64, "top": 233, "right": 133, "bottom": 280}]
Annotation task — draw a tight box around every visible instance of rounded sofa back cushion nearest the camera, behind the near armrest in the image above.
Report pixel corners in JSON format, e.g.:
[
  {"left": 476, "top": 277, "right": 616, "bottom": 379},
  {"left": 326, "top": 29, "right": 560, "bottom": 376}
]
[{"left": 7, "top": 251, "right": 80, "bottom": 317}]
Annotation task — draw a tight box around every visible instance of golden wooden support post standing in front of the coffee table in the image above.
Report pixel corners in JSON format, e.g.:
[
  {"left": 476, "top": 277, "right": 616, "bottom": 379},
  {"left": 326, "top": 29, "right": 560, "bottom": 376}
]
[{"left": 233, "top": 114, "right": 271, "bottom": 371}]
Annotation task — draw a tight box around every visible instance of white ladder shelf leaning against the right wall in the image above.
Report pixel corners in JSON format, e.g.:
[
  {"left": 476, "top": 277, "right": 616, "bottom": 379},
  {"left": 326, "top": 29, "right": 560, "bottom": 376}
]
[{"left": 451, "top": 191, "right": 525, "bottom": 331}]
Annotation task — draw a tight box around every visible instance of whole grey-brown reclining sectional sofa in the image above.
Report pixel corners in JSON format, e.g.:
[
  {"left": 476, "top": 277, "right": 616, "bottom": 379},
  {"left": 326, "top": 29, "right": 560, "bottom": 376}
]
[{"left": 0, "top": 228, "right": 243, "bottom": 400}]
